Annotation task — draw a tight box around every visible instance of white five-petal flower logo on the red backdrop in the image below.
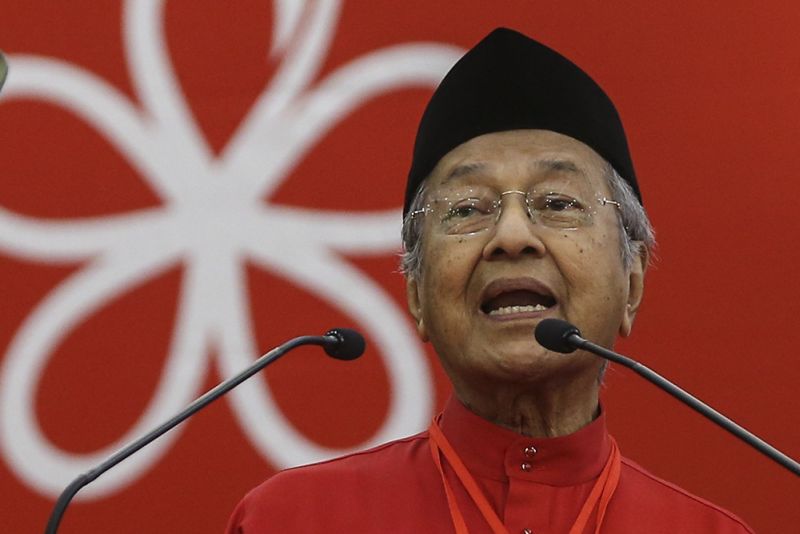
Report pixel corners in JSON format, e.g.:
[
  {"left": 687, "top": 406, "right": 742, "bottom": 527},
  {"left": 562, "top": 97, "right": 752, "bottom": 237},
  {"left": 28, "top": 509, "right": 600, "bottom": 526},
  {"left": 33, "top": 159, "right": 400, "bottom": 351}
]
[{"left": 0, "top": 0, "right": 460, "bottom": 497}]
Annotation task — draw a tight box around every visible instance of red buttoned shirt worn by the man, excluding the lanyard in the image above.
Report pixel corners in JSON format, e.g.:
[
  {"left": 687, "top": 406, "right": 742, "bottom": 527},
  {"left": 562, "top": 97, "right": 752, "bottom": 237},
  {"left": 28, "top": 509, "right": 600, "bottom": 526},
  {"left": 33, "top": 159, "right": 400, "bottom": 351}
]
[{"left": 228, "top": 398, "right": 752, "bottom": 534}]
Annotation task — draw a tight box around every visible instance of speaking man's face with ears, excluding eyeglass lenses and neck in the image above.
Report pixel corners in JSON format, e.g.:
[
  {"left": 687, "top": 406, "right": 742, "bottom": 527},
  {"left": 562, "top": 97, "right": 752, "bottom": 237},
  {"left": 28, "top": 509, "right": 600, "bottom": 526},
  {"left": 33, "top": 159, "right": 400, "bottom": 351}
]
[{"left": 408, "top": 130, "right": 644, "bottom": 388}]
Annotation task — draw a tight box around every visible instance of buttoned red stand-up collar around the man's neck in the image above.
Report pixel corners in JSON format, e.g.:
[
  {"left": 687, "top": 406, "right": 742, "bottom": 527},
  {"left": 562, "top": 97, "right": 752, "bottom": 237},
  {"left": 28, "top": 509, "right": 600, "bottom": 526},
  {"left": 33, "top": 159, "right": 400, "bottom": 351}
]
[{"left": 440, "top": 396, "right": 611, "bottom": 486}]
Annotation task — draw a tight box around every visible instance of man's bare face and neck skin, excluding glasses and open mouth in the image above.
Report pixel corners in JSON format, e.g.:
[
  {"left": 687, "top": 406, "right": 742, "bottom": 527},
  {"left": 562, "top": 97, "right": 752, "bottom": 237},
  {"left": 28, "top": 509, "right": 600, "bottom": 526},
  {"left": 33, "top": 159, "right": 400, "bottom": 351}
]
[{"left": 407, "top": 130, "right": 647, "bottom": 436}]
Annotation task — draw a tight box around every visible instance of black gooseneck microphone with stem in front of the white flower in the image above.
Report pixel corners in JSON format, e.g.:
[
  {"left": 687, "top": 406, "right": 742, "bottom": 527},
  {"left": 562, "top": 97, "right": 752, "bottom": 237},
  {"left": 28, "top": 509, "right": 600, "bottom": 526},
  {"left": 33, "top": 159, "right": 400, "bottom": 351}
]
[{"left": 45, "top": 328, "right": 366, "bottom": 534}]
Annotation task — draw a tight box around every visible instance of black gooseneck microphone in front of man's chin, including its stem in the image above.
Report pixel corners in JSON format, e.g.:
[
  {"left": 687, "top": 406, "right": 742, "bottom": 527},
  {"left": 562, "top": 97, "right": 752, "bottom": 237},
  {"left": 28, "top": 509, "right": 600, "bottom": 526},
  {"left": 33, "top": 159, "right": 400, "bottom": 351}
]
[{"left": 534, "top": 319, "right": 800, "bottom": 476}]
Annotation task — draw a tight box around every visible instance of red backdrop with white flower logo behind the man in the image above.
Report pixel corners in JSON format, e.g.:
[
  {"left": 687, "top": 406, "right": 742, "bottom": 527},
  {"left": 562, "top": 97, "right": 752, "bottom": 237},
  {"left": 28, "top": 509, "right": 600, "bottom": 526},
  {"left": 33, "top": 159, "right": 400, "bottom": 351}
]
[{"left": 0, "top": 0, "right": 800, "bottom": 533}]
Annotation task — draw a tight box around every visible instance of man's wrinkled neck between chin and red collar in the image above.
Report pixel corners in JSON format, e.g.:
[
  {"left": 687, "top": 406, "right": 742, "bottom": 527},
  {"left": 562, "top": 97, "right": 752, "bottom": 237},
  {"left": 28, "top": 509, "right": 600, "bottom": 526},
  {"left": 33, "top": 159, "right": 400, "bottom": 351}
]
[{"left": 455, "top": 378, "right": 600, "bottom": 437}]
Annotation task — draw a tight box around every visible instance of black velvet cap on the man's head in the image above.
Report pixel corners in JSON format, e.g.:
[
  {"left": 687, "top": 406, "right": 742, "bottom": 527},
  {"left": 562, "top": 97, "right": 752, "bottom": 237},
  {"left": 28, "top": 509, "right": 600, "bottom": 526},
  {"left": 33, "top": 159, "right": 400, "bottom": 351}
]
[{"left": 403, "top": 28, "right": 642, "bottom": 215}]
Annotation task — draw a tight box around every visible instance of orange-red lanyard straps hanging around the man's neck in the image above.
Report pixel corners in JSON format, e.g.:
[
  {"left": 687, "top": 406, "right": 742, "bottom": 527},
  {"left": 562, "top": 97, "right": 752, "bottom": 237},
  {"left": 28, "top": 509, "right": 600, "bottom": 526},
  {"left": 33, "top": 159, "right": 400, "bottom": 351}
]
[{"left": 428, "top": 418, "right": 621, "bottom": 534}]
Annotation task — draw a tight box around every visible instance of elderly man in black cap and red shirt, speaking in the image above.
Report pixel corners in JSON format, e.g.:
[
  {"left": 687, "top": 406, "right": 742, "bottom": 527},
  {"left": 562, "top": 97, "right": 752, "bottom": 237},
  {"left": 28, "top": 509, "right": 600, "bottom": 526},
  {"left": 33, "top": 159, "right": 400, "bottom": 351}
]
[{"left": 229, "top": 29, "right": 751, "bottom": 534}]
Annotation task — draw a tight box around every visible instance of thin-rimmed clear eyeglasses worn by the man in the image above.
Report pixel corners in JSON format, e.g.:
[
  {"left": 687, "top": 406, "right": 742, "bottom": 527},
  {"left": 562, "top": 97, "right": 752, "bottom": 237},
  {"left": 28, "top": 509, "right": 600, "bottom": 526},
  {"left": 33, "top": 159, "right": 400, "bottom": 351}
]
[{"left": 410, "top": 184, "right": 619, "bottom": 235}]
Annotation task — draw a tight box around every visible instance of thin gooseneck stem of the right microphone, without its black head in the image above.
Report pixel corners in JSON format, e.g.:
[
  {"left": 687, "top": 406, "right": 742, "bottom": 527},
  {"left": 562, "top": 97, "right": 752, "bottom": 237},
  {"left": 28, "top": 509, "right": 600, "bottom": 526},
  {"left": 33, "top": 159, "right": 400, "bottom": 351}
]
[{"left": 564, "top": 331, "right": 800, "bottom": 476}]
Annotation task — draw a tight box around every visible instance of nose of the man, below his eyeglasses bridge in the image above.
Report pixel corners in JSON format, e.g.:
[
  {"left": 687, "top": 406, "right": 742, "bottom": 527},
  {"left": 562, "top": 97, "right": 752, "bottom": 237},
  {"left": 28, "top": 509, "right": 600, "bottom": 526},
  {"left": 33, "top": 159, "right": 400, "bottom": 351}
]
[{"left": 483, "top": 191, "right": 546, "bottom": 260}]
